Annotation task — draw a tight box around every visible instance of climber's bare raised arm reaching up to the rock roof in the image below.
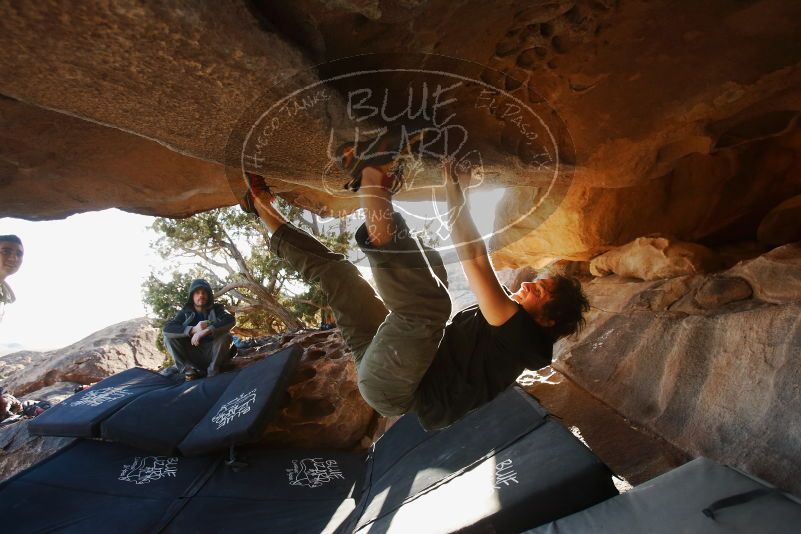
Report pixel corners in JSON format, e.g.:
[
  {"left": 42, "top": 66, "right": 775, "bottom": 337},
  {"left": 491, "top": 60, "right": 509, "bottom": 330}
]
[{"left": 442, "top": 160, "right": 517, "bottom": 326}]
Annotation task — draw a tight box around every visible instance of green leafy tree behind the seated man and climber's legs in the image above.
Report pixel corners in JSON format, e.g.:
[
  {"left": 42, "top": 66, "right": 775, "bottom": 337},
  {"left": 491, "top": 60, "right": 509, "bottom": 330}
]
[{"left": 143, "top": 200, "right": 352, "bottom": 342}]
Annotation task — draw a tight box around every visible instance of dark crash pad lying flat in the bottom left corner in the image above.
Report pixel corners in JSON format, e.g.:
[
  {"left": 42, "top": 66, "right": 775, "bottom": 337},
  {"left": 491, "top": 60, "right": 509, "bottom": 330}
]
[{"left": 0, "top": 440, "right": 216, "bottom": 534}]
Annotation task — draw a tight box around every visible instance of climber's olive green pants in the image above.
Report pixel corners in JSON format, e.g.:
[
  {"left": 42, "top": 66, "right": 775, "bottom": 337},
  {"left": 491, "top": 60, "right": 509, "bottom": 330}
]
[{"left": 270, "top": 214, "right": 451, "bottom": 415}]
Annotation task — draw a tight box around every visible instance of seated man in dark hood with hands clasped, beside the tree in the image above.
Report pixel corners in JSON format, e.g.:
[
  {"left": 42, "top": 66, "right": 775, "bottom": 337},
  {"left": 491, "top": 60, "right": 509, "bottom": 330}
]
[{"left": 164, "top": 278, "right": 236, "bottom": 380}]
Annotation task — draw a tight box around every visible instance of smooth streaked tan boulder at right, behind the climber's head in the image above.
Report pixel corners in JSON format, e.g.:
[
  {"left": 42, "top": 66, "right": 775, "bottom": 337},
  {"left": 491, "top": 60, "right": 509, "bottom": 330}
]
[{"left": 554, "top": 244, "right": 801, "bottom": 493}]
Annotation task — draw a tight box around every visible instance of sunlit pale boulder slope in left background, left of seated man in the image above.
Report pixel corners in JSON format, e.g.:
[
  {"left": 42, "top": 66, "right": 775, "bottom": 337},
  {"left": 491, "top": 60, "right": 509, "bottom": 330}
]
[{"left": 0, "top": 317, "right": 164, "bottom": 396}]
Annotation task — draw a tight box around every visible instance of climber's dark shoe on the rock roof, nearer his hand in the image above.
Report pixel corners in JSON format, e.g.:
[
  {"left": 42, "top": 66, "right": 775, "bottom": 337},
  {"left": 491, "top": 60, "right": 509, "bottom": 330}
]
[{"left": 335, "top": 126, "right": 425, "bottom": 194}]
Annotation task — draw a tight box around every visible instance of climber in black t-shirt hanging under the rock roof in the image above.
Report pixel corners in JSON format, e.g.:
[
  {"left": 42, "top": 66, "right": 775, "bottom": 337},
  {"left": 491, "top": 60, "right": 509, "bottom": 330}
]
[{"left": 242, "top": 130, "right": 589, "bottom": 429}]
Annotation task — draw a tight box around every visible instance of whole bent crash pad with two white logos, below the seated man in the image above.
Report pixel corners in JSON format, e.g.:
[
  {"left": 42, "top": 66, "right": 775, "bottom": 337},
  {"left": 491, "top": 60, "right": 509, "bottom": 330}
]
[{"left": 29, "top": 345, "right": 303, "bottom": 455}]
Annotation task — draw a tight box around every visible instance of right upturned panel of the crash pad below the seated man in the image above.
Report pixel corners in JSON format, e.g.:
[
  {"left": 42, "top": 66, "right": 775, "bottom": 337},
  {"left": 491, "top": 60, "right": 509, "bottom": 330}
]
[{"left": 178, "top": 345, "right": 303, "bottom": 456}]
